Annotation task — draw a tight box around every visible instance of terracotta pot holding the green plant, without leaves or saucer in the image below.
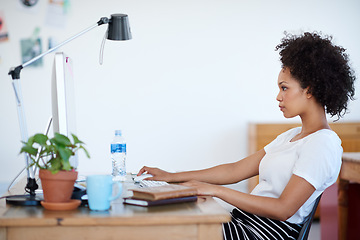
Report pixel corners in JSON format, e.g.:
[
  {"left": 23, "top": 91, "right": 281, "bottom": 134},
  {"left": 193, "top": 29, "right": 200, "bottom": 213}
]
[{"left": 39, "top": 169, "right": 78, "bottom": 203}]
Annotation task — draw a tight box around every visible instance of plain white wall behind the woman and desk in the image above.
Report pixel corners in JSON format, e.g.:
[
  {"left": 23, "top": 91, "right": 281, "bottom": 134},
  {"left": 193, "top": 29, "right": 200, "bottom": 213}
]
[{"left": 0, "top": 0, "right": 360, "bottom": 188}]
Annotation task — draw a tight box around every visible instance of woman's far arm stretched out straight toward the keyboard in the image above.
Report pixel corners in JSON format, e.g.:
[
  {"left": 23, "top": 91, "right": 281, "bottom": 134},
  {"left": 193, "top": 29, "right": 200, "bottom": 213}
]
[{"left": 138, "top": 149, "right": 265, "bottom": 185}]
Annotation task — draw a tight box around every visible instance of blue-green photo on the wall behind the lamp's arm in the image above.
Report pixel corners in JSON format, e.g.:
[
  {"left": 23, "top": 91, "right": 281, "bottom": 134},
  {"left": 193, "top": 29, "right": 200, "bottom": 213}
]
[{"left": 20, "top": 38, "right": 43, "bottom": 67}]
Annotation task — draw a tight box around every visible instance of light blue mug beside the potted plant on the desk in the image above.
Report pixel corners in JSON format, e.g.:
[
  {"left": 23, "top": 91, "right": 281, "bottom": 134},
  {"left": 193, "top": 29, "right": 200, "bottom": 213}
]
[{"left": 86, "top": 175, "right": 122, "bottom": 211}]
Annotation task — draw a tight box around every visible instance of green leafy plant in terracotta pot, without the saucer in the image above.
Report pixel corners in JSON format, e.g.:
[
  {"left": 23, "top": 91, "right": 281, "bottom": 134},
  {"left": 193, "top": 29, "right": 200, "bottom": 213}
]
[{"left": 20, "top": 133, "right": 90, "bottom": 203}]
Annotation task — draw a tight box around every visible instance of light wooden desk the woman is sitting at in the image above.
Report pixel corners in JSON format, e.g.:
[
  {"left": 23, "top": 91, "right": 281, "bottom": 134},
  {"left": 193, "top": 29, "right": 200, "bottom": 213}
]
[{"left": 0, "top": 178, "right": 230, "bottom": 240}]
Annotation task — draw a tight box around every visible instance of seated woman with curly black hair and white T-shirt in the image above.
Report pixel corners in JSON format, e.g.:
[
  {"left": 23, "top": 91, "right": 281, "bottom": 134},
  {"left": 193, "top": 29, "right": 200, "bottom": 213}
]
[{"left": 138, "top": 33, "right": 355, "bottom": 239}]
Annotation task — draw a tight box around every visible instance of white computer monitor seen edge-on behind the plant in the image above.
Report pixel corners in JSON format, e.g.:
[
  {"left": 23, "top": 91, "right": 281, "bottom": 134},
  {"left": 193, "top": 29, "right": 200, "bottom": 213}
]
[{"left": 51, "top": 52, "right": 78, "bottom": 168}]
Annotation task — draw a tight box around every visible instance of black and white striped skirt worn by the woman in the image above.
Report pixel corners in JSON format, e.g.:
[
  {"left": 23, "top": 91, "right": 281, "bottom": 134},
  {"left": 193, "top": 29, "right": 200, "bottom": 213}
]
[{"left": 223, "top": 208, "right": 302, "bottom": 240}]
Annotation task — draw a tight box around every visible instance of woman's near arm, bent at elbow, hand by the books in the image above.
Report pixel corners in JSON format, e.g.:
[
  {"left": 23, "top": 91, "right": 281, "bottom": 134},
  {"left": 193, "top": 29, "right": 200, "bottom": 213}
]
[{"left": 184, "top": 172, "right": 315, "bottom": 221}]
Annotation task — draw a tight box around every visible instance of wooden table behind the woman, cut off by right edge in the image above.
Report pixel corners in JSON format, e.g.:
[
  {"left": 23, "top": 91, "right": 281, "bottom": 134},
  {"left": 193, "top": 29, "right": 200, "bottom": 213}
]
[{"left": 338, "top": 152, "right": 360, "bottom": 240}]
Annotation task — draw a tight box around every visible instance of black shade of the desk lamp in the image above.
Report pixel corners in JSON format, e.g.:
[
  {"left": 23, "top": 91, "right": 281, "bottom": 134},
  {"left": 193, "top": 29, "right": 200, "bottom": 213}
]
[{"left": 107, "top": 14, "right": 131, "bottom": 41}]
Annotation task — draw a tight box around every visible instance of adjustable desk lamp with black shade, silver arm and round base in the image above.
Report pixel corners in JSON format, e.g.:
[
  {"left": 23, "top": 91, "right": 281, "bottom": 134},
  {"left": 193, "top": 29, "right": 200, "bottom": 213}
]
[{"left": 6, "top": 14, "right": 131, "bottom": 206}]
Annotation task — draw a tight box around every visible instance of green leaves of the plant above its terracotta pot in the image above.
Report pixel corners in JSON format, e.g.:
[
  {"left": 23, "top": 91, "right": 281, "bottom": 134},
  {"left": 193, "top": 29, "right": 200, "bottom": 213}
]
[{"left": 20, "top": 133, "right": 90, "bottom": 174}]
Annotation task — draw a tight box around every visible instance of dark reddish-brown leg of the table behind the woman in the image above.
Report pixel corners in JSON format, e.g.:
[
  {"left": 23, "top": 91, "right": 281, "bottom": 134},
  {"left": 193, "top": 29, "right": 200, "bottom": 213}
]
[{"left": 338, "top": 179, "right": 349, "bottom": 240}]
